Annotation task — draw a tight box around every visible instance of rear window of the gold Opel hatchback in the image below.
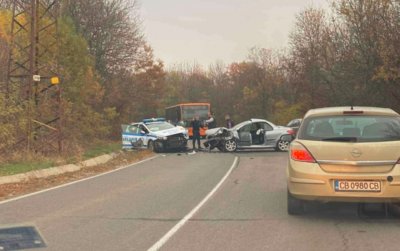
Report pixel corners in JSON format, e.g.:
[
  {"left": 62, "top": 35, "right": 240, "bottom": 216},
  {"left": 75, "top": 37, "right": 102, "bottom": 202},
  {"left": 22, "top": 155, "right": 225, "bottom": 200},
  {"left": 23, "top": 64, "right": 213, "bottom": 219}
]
[{"left": 298, "top": 115, "right": 400, "bottom": 142}]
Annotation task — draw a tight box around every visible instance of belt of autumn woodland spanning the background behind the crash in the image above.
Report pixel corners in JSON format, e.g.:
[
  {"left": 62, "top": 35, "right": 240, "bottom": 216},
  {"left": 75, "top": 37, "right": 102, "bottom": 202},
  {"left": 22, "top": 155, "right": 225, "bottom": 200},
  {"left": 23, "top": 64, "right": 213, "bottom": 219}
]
[{"left": 0, "top": 0, "right": 400, "bottom": 159}]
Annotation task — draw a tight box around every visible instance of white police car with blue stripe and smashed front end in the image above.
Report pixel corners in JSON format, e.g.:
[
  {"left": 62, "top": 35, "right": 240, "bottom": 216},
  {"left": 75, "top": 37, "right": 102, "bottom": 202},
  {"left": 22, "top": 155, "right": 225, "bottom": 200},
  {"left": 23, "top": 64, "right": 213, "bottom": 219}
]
[{"left": 122, "top": 118, "right": 189, "bottom": 152}]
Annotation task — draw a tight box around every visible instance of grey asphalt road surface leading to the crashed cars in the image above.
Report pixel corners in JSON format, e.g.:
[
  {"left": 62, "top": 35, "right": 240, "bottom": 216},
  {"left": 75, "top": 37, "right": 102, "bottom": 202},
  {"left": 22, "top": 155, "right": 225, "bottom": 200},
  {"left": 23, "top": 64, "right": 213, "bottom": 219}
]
[{"left": 0, "top": 152, "right": 400, "bottom": 251}]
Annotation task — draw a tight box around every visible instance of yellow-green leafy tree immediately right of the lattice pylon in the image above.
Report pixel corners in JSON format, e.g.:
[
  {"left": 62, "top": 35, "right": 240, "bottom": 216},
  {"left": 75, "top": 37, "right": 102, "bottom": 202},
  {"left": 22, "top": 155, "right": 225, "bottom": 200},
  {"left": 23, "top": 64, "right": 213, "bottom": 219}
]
[{"left": 55, "top": 18, "right": 116, "bottom": 151}]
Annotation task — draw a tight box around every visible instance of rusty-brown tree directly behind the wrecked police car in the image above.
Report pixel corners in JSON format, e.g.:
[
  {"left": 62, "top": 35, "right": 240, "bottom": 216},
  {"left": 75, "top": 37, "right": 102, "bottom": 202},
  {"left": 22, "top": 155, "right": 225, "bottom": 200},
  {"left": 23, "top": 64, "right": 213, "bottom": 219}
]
[{"left": 105, "top": 46, "right": 165, "bottom": 133}]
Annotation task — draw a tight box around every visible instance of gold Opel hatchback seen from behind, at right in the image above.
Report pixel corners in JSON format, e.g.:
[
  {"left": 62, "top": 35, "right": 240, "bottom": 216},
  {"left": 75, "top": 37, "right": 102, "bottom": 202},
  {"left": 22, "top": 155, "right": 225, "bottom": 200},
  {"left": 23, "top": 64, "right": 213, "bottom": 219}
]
[{"left": 287, "top": 107, "right": 400, "bottom": 214}]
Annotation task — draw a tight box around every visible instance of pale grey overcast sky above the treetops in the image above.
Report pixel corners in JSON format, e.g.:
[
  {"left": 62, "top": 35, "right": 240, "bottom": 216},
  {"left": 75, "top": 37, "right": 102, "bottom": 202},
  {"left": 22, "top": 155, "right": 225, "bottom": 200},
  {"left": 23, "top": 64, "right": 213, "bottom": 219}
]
[{"left": 140, "top": 0, "right": 328, "bottom": 67}]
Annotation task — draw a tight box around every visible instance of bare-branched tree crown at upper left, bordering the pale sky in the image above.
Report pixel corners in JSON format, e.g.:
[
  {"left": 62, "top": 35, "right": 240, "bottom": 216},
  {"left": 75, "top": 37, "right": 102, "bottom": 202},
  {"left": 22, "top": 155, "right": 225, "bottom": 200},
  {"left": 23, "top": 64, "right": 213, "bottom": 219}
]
[{"left": 63, "top": 0, "right": 144, "bottom": 77}]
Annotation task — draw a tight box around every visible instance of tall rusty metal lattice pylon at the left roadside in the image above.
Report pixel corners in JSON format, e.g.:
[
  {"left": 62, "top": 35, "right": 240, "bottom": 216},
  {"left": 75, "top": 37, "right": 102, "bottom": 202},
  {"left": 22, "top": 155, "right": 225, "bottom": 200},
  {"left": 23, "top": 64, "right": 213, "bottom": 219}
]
[{"left": 5, "top": 0, "right": 62, "bottom": 154}]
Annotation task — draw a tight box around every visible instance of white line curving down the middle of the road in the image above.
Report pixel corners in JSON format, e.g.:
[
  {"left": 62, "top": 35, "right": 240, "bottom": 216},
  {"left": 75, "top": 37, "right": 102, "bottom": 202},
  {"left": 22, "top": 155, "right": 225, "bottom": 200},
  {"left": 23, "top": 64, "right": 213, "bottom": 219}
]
[{"left": 147, "top": 156, "right": 239, "bottom": 251}]
